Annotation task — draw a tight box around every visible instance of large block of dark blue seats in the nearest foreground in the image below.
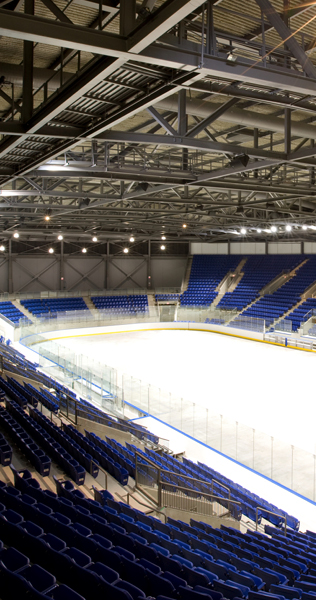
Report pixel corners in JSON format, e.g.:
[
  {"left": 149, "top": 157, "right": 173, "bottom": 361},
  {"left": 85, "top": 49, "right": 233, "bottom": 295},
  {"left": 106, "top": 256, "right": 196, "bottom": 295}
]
[{"left": 0, "top": 469, "right": 316, "bottom": 600}]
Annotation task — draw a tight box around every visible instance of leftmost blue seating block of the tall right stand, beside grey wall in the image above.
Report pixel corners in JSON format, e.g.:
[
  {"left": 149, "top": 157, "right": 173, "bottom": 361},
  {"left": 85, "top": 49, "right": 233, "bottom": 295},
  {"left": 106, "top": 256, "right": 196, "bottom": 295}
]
[{"left": 181, "top": 254, "right": 242, "bottom": 306}]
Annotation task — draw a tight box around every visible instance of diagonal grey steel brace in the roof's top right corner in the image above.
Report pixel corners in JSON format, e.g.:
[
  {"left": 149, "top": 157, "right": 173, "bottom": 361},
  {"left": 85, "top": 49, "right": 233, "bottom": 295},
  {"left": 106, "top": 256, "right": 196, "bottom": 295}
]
[{"left": 256, "top": 0, "right": 316, "bottom": 79}]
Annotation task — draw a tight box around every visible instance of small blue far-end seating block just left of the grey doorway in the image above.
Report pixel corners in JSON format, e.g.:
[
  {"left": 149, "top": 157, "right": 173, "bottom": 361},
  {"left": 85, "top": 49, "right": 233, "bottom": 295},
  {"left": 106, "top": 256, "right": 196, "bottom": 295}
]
[{"left": 91, "top": 294, "right": 148, "bottom": 316}]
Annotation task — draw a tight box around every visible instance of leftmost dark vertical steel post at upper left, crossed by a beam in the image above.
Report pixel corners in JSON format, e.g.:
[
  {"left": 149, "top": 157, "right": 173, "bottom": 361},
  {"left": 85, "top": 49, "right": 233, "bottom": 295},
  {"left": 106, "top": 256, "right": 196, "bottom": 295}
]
[{"left": 22, "top": 0, "right": 34, "bottom": 123}]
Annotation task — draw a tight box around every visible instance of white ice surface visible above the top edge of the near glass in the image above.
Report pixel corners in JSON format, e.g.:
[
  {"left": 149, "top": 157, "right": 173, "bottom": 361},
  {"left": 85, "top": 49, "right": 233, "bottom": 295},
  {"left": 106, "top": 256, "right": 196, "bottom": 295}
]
[{"left": 58, "top": 330, "right": 316, "bottom": 453}]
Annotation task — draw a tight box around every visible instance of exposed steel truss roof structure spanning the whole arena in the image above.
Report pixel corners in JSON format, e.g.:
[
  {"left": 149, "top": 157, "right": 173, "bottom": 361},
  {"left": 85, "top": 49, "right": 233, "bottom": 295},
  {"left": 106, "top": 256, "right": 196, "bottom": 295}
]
[{"left": 0, "top": 0, "right": 316, "bottom": 247}]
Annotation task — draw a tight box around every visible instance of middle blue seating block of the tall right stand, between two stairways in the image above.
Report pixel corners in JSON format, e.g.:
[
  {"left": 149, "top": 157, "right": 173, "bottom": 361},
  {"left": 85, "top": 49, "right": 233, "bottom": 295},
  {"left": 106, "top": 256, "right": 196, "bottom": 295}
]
[{"left": 217, "top": 255, "right": 302, "bottom": 310}]
